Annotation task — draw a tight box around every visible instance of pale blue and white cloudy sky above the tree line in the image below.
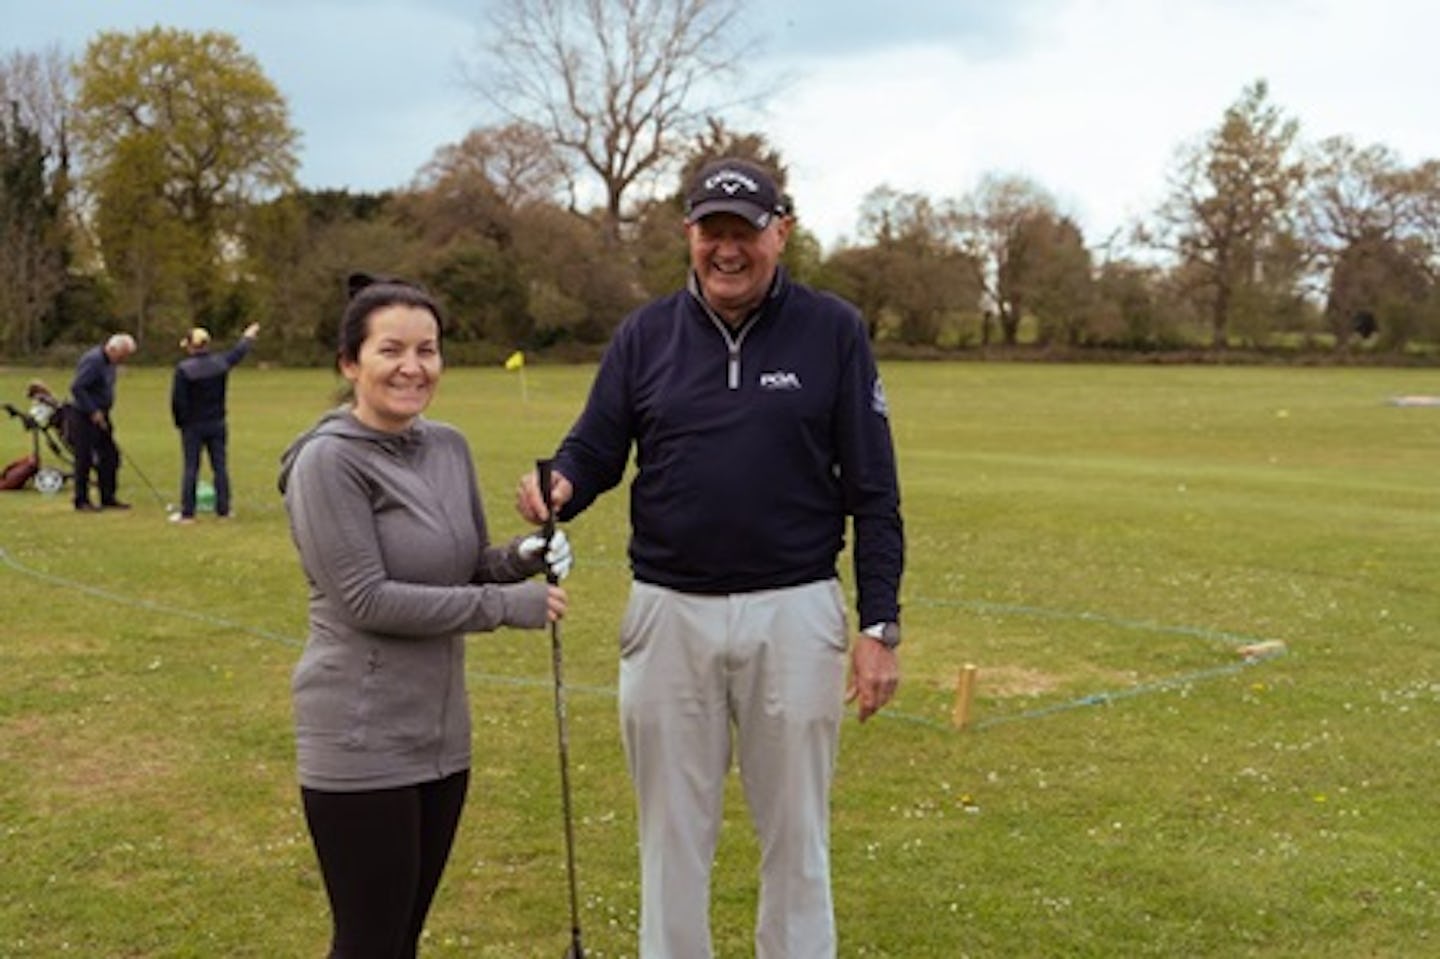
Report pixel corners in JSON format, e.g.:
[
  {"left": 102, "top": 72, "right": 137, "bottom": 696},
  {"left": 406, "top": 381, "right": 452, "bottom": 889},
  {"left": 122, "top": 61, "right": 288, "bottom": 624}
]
[{"left": 0, "top": 0, "right": 1440, "bottom": 248}]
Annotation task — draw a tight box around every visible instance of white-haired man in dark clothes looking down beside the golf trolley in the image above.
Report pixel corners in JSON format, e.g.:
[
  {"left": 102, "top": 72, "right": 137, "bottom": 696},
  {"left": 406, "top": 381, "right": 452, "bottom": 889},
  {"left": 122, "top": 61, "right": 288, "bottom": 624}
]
[{"left": 69, "top": 333, "right": 135, "bottom": 513}]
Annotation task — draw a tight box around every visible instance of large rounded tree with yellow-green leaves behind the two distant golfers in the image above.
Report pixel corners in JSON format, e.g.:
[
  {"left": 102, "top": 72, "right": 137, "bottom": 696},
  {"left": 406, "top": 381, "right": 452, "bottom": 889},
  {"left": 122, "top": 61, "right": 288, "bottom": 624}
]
[{"left": 75, "top": 27, "right": 297, "bottom": 339}]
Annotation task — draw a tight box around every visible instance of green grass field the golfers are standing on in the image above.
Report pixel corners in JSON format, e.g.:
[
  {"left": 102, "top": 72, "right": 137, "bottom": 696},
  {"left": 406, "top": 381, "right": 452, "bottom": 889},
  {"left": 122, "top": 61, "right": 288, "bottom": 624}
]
[{"left": 0, "top": 364, "right": 1440, "bottom": 959}]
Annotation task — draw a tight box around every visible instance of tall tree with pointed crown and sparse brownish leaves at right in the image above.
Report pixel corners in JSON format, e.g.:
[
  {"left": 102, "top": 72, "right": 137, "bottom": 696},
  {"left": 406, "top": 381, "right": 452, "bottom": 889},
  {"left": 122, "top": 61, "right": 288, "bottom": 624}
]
[{"left": 1142, "top": 81, "right": 1305, "bottom": 348}]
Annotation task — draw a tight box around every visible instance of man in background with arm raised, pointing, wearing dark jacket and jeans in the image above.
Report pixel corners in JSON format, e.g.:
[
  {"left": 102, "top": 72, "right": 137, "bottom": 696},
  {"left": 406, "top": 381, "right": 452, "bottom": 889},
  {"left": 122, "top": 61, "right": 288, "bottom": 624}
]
[{"left": 170, "top": 323, "right": 261, "bottom": 524}]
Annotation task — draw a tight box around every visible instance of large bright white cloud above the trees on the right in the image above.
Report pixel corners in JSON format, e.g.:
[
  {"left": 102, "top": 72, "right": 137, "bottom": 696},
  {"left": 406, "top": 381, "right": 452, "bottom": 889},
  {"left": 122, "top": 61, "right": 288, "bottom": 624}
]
[{"left": 755, "top": 0, "right": 1440, "bottom": 246}]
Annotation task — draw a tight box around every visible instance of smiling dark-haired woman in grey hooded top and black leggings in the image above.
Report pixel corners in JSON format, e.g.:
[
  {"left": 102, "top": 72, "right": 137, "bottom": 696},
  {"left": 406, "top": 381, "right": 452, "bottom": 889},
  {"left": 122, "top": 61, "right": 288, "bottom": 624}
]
[{"left": 279, "top": 275, "right": 570, "bottom": 959}]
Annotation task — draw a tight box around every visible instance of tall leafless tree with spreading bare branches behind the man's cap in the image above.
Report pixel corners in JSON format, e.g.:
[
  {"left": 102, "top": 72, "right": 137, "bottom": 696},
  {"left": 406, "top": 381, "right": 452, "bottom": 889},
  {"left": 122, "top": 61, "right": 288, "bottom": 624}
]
[{"left": 477, "top": 0, "right": 744, "bottom": 240}]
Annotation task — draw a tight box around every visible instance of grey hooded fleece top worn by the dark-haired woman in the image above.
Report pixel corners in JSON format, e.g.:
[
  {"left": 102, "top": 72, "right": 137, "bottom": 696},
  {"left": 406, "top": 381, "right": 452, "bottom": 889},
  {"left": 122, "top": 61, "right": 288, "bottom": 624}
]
[{"left": 279, "top": 409, "right": 546, "bottom": 792}]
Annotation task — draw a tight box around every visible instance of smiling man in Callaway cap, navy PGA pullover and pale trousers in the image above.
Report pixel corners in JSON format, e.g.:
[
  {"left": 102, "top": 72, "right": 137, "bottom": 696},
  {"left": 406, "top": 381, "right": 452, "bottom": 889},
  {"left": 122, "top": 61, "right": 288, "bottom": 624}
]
[{"left": 517, "top": 160, "right": 904, "bottom": 959}]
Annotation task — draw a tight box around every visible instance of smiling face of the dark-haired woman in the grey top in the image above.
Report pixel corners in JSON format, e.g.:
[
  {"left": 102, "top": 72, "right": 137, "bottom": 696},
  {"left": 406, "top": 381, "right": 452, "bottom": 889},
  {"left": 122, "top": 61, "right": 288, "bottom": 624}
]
[{"left": 340, "top": 304, "right": 445, "bottom": 432}]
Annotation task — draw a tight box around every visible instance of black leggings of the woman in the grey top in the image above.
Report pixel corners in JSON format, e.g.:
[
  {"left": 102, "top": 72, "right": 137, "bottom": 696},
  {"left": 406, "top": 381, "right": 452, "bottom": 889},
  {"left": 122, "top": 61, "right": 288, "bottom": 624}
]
[{"left": 300, "top": 770, "right": 469, "bottom": 959}]
